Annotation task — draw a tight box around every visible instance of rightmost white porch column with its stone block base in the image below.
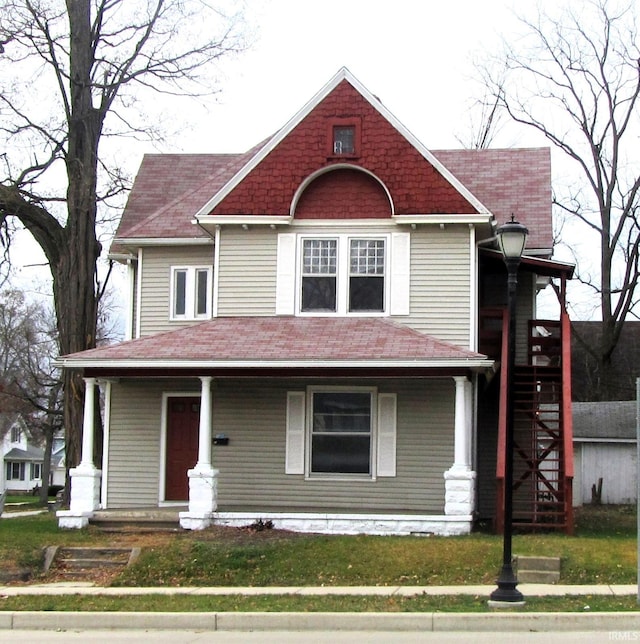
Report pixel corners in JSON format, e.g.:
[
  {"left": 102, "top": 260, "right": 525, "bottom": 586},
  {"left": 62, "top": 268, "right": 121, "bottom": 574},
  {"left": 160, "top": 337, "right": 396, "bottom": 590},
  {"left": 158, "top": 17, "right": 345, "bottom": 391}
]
[{"left": 444, "top": 376, "right": 476, "bottom": 529}]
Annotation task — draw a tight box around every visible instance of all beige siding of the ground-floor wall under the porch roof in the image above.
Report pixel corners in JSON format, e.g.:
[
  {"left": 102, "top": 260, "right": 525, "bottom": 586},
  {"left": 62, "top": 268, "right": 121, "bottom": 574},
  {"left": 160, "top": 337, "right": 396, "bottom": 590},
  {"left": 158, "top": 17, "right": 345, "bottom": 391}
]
[{"left": 108, "top": 378, "right": 455, "bottom": 518}]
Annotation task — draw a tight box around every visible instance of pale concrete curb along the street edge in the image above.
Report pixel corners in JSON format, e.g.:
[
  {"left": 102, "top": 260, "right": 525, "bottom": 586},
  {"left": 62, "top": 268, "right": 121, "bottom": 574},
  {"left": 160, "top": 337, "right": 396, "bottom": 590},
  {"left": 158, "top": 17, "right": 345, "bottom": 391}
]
[{"left": 0, "top": 611, "right": 640, "bottom": 632}]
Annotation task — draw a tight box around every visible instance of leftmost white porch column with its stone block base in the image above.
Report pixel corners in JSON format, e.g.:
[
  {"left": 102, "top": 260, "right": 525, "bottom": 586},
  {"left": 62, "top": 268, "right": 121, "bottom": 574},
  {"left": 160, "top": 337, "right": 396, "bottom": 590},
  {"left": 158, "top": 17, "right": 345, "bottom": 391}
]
[{"left": 57, "top": 378, "right": 102, "bottom": 528}]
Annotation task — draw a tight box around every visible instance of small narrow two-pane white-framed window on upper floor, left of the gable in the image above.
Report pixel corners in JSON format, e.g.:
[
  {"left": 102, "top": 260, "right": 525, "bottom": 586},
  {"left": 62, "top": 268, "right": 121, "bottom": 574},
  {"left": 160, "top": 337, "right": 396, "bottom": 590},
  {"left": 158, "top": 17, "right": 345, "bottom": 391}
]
[{"left": 171, "top": 266, "right": 212, "bottom": 320}]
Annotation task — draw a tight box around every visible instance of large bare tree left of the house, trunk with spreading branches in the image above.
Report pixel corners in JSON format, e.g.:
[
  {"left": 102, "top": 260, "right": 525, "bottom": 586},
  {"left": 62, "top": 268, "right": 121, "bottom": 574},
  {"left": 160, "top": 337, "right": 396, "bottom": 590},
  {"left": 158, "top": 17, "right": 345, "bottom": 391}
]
[{"left": 0, "top": 0, "right": 249, "bottom": 478}]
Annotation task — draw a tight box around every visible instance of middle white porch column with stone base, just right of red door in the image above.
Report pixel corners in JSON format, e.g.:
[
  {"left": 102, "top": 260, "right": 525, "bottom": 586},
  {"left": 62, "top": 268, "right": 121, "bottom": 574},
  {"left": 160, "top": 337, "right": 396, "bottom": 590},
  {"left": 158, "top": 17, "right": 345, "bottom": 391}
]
[{"left": 180, "top": 376, "right": 218, "bottom": 530}]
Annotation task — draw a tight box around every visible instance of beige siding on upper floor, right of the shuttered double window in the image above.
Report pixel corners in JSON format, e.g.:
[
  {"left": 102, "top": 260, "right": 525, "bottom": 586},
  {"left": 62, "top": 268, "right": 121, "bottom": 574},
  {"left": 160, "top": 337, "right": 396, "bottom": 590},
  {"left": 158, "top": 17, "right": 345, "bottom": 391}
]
[{"left": 400, "top": 225, "right": 475, "bottom": 348}]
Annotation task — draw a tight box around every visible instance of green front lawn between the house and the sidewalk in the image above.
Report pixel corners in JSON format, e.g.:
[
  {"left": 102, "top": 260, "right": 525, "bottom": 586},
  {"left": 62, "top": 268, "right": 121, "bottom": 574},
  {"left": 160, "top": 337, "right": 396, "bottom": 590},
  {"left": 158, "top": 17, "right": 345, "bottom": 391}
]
[{"left": 0, "top": 506, "right": 637, "bottom": 587}]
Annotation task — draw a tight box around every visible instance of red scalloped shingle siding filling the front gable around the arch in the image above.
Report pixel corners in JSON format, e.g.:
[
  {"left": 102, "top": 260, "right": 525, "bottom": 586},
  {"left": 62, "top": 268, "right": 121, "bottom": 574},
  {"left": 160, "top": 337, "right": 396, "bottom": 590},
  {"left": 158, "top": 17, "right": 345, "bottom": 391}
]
[{"left": 213, "top": 81, "right": 475, "bottom": 215}]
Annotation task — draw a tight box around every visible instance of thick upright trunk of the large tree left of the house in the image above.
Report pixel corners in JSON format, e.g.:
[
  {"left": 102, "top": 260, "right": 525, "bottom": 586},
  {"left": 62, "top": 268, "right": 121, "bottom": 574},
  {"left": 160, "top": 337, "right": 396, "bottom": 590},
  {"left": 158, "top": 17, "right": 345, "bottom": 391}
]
[{"left": 52, "top": 0, "right": 103, "bottom": 467}]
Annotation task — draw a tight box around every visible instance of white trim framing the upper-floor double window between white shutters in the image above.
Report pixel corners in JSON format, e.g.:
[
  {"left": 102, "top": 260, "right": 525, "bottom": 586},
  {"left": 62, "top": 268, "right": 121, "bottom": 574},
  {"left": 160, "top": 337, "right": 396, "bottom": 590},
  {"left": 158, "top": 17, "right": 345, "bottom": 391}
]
[{"left": 295, "top": 231, "right": 391, "bottom": 317}]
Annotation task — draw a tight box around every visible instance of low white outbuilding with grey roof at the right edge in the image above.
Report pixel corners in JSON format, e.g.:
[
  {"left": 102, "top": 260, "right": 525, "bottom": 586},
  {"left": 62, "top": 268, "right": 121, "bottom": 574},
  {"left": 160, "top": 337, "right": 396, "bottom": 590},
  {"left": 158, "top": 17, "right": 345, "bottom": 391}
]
[{"left": 573, "top": 400, "right": 638, "bottom": 505}]
